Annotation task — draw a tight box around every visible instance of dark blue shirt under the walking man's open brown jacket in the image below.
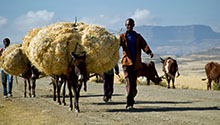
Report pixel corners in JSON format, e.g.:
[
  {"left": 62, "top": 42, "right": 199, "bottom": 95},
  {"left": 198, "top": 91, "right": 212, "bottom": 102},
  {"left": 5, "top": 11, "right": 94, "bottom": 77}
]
[{"left": 126, "top": 32, "right": 136, "bottom": 65}]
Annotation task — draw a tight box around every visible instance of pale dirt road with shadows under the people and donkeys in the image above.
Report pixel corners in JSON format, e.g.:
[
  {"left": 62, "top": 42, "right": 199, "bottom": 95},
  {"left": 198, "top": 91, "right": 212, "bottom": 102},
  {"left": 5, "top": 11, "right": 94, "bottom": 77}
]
[{"left": 0, "top": 78, "right": 220, "bottom": 125}]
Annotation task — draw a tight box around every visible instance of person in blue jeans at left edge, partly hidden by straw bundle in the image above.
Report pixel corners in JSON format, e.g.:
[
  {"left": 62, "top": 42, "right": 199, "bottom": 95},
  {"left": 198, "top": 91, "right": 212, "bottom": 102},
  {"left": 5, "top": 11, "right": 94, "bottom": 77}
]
[{"left": 0, "top": 38, "right": 13, "bottom": 98}]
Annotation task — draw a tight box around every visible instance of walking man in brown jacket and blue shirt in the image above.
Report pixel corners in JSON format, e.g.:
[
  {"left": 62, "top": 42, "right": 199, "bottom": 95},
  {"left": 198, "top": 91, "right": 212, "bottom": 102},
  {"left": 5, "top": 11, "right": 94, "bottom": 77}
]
[{"left": 120, "top": 18, "right": 153, "bottom": 109}]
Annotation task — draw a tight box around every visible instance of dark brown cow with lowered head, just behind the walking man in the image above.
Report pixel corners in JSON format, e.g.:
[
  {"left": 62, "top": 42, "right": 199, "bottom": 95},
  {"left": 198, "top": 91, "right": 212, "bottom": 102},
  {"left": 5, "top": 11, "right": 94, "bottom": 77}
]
[{"left": 137, "top": 61, "right": 162, "bottom": 85}]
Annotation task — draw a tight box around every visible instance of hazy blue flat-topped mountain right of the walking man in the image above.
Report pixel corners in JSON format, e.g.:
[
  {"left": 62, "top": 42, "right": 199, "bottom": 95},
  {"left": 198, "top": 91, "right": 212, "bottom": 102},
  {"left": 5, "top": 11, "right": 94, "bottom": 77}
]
[{"left": 135, "top": 25, "right": 220, "bottom": 56}]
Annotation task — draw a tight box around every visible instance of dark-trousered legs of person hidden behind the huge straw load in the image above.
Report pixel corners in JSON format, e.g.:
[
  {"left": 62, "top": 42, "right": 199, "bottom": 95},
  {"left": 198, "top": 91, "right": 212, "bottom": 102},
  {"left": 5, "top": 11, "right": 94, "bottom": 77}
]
[{"left": 102, "top": 64, "right": 119, "bottom": 102}]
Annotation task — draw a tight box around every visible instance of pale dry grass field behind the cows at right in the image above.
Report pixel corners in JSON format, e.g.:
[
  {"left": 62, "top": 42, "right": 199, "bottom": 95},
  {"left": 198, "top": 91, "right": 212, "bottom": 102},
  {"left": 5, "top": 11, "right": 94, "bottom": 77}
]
[{"left": 115, "top": 47, "right": 220, "bottom": 90}]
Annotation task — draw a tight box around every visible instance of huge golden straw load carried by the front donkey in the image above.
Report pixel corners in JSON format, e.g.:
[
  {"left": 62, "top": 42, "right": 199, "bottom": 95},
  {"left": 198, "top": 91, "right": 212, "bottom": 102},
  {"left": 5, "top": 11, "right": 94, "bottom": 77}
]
[{"left": 22, "top": 22, "right": 119, "bottom": 75}]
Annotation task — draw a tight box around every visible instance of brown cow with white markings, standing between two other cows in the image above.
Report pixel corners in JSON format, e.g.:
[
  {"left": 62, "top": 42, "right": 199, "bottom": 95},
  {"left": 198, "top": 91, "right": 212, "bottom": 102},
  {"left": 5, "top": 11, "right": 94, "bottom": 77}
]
[{"left": 159, "top": 57, "right": 180, "bottom": 89}]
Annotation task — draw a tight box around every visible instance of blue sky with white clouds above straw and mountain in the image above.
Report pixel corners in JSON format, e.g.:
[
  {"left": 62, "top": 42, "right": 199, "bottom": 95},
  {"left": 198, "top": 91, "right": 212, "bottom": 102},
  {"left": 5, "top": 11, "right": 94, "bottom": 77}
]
[{"left": 0, "top": 0, "right": 220, "bottom": 43}]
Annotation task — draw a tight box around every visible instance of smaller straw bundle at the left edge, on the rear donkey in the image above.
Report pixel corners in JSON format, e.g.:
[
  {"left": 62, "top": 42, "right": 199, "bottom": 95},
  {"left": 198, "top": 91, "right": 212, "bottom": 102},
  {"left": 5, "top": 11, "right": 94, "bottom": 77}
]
[{"left": 0, "top": 44, "right": 30, "bottom": 75}]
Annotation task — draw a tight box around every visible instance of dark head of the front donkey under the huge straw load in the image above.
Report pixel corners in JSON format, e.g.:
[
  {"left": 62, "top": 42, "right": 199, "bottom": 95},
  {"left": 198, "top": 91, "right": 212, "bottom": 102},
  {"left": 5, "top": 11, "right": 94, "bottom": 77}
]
[{"left": 71, "top": 52, "right": 87, "bottom": 81}]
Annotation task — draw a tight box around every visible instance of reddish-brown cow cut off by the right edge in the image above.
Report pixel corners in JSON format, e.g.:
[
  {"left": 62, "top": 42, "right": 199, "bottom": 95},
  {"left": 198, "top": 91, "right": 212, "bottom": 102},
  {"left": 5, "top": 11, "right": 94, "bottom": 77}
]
[{"left": 202, "top": 62, "right": 220, "bottom": 90}]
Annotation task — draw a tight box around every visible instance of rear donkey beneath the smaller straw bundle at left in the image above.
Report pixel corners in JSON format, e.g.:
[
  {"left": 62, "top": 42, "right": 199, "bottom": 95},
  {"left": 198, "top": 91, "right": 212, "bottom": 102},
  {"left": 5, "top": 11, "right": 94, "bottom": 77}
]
[{"left": 20, "top": 65, "right": 41, "bottom": 97}]
